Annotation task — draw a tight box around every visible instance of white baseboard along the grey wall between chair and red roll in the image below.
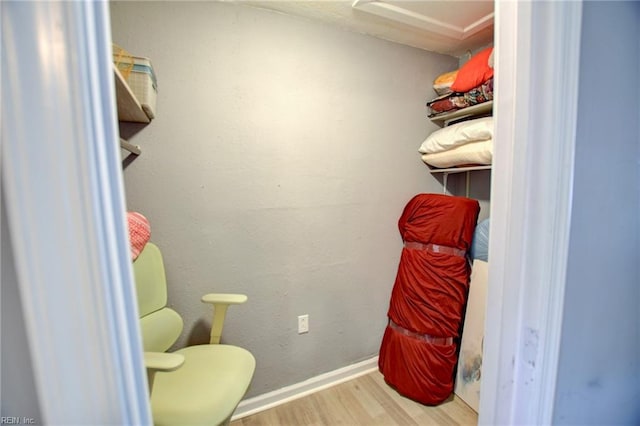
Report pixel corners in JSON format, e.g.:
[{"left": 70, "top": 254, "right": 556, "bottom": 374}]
[{"left": 231, "top": 356, "right": 378, "bottom": 421}]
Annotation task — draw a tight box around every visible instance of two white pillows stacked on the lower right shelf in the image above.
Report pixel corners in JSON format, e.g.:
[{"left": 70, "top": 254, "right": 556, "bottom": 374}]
[{"left": 418, "top": 117, "right": 493, "bottom": 168}]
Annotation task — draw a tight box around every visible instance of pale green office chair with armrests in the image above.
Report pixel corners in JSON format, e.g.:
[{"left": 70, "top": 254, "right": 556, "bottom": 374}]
[{"left": 133, "top": 242, "right": 256, "bottom": 426}]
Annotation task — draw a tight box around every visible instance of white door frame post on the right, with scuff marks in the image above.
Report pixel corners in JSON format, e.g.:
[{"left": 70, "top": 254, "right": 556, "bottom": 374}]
[{"left": 479, "top": 0, "right": 582, "bottom": 425}]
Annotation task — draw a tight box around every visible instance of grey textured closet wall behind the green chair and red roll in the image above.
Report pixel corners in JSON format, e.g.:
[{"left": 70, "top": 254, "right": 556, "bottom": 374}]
[{"left": 111, "top": 2, "right": 458, "bottom": 396}]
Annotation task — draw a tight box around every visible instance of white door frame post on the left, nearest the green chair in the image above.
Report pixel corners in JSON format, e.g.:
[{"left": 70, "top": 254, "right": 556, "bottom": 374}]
[{"left": 0, "top": 1, "right": 151, "bottom": 425}]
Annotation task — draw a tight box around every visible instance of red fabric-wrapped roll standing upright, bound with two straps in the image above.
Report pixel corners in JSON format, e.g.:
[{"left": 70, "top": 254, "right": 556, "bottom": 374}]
[{"left": 378, "top": 194, "right": 480, "bottom": 405}]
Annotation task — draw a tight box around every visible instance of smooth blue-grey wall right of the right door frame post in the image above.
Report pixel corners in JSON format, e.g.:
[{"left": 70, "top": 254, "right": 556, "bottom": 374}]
[{"left": 554, "top": 1, "right": 640, "bottom": 425}]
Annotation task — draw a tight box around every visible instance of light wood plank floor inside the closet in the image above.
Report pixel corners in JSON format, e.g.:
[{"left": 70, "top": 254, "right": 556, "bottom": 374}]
[{"left": 231, "top": 371, "right": 478, "bottom": 426}]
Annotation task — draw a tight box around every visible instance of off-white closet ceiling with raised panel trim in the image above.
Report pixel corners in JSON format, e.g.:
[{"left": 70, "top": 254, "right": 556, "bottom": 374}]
[{"left": 238, "top": 0, "right": 494, "bottom": 57}]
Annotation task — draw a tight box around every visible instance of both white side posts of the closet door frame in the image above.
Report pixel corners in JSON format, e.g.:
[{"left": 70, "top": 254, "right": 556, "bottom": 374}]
[{"left": 1, "top": 1, "right": 582, "bottom": 424}]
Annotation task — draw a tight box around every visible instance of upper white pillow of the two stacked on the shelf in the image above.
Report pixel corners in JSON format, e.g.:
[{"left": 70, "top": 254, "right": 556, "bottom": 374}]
[{"left": 418, "top": 117, "right": 493, "bottom": 154}]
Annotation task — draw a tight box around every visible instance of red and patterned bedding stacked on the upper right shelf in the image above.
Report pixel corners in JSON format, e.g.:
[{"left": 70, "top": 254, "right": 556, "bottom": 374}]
[{"left": 427, "top": 47, "right": 493, "bottom": 117}]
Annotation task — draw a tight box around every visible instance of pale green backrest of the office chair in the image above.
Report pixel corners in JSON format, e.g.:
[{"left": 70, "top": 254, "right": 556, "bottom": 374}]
[{"left": 133, "top": 242, "right": 183, "bottom": 352}]
